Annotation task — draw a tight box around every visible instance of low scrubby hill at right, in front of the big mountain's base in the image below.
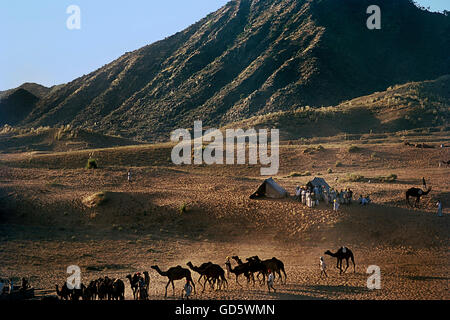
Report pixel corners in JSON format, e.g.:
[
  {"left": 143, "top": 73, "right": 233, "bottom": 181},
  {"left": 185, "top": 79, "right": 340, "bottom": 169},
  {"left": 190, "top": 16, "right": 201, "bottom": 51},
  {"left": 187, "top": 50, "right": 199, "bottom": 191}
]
[{"left": 224, "top": 75, "right": 450, "bottom": 140}]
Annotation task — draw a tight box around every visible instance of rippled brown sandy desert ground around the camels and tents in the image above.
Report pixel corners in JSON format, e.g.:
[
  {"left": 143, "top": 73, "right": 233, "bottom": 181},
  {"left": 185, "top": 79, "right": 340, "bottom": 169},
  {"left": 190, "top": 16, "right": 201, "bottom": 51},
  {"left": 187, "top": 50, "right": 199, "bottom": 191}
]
[{"left": 0, "top": 138, "right": 450, "bottom": 300}]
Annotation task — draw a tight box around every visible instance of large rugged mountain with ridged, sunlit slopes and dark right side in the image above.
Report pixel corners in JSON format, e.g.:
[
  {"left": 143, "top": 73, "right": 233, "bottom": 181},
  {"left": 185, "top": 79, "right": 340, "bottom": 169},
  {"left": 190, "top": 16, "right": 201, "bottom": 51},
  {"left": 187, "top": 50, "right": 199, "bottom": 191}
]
[{"left": 9, "top": 0, "right": 450, "bottom": 141}]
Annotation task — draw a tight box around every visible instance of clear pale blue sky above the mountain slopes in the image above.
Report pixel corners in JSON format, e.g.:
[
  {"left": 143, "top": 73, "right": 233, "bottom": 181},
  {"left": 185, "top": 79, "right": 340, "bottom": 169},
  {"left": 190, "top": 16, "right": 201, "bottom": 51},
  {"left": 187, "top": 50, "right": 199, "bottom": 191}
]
[{"left": 0, "top": 0, "right": 450, "bottom": 91}]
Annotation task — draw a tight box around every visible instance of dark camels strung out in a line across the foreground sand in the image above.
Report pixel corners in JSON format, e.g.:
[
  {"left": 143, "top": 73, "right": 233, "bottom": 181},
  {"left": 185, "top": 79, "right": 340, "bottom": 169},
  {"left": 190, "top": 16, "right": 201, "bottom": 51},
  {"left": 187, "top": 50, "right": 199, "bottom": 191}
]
[{"left": 56, "top": 247, "right": 356, "bottom": 300}]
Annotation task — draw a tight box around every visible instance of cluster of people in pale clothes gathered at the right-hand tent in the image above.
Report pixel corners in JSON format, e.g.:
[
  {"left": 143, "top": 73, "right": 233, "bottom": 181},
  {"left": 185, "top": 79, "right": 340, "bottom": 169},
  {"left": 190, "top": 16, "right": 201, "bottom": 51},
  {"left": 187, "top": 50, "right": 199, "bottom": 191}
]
[{"left": 295, "top": 185, "right": 356, "bottom": 210}]
